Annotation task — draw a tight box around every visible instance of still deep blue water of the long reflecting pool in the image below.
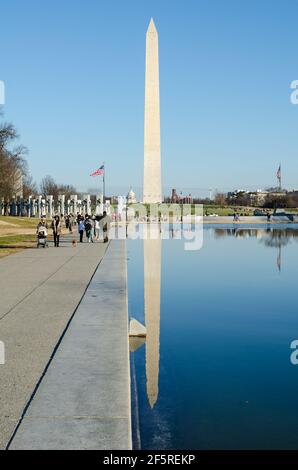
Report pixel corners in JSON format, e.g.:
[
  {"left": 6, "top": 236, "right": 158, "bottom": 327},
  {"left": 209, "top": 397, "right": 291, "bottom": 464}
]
[{"left": 127, "top": 226, "right": 298, "bottom": 449}]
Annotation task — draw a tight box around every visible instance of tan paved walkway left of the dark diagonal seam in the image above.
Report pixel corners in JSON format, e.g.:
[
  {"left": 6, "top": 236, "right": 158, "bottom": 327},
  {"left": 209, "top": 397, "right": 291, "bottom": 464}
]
[{"left": 0, "top": 236, "right": 106, "bottom": 449}]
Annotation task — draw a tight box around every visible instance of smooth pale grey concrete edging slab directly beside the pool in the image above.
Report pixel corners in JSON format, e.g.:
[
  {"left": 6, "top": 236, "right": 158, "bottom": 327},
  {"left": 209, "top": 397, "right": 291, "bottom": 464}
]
[{"left": 10, "top": 241, "right": 132, "bottom": 449}]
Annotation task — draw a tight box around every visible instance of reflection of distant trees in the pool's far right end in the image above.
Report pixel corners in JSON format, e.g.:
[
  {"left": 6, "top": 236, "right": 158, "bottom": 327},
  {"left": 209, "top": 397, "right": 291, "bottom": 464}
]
[{"left": 214, "top": 227, "right": 298, "bottom": 248}]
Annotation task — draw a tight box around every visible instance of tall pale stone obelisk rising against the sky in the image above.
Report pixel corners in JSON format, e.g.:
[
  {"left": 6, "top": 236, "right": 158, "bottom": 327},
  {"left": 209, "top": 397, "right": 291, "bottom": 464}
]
[{"left": 143, "top": 19, "right": 162, "bottom": 204}]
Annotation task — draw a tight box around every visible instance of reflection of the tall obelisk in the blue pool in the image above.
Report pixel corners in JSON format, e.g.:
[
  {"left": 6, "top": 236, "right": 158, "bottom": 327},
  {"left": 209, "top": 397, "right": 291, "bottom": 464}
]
[{"left": 144, "top": 236, "right": 161, "bottom": 408}]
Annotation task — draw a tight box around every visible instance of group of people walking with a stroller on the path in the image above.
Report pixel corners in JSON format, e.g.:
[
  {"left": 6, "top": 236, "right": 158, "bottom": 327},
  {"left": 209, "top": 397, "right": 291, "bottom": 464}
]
[{"left": 36, "top": 211, "right": 110, "bottom": 247}]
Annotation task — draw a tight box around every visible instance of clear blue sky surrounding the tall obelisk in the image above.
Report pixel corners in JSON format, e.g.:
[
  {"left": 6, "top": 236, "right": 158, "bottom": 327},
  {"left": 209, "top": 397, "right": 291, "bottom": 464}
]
[{"left": 0, "top": 0, "right": 298, "bottom": 195}]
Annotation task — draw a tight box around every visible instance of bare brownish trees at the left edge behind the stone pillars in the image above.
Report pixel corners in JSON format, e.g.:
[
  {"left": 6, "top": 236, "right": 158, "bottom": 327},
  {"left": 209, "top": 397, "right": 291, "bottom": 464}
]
[{"left": 0, "top": 108, "right": 77, "bottom": 201}]
